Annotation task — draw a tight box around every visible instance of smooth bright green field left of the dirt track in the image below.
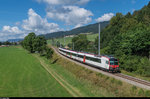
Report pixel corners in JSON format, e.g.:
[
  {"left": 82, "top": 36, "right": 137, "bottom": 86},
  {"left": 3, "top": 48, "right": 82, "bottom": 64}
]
[{"left": 0, "top": 47, "right": 72, "bottom": 97}]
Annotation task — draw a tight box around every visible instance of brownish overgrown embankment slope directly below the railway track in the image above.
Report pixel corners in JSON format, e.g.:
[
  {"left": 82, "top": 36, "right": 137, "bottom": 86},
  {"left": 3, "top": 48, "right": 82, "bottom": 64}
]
[{"left": 47, "top": 45, "right": 150, "bottom": 97}]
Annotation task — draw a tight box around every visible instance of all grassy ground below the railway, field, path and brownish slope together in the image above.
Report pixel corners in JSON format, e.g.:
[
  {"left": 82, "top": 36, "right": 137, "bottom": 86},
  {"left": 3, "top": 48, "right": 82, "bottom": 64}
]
[{"left": 0, "top": 46, "right": 150, "bottom": 97}]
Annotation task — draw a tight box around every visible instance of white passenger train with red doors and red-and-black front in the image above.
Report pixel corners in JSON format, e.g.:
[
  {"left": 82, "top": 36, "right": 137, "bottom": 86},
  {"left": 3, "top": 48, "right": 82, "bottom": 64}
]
[{"left": 59, "top": 48, "right": 120, "bottom": 72}]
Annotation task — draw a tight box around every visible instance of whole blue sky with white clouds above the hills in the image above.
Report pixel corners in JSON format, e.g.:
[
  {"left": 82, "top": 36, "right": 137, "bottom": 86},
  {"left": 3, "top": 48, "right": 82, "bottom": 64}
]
[{"left": 0, "top": 0, "right": 150, "bottom": 41}]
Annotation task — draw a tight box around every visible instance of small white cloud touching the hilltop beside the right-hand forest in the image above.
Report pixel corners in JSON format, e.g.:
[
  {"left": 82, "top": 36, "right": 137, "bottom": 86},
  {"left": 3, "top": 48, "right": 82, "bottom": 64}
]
[{"left": 95, "top": 13, "right": 114, "bottom": 22}]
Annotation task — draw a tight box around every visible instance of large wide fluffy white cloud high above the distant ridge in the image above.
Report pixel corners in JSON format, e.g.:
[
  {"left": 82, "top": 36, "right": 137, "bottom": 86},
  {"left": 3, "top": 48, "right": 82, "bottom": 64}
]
[{"left": 47, "top": 6, "right": 93, "bottom": 27}]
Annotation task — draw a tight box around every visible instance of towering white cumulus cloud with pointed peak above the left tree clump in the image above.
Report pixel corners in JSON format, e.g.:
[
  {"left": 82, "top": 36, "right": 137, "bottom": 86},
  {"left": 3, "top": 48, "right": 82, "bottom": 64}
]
[{"left": 22, "top": 9, "right": 60, "bottom": 35}]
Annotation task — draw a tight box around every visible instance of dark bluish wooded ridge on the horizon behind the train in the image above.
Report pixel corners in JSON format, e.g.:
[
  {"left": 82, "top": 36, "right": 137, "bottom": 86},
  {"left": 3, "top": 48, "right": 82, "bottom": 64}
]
[{"left": 43, "top": 21, "right": 109, "bottom": 39}]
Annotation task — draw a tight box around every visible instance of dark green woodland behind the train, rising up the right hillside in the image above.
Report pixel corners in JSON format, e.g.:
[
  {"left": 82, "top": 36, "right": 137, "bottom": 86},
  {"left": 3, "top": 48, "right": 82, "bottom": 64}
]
[{"left": 64, "top": 2, "right": 150, "bottom": 77}]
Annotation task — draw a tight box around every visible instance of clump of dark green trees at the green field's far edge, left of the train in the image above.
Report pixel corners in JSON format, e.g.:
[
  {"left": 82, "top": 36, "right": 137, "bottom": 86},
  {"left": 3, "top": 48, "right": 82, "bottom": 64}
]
[{"left": 21, "top": 32, "right": 53, "bottom": 59}]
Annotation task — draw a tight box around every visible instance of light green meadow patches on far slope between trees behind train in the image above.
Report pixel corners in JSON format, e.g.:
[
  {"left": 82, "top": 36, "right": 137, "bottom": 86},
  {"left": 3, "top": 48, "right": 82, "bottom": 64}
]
[{"left": 47, "top": 34, "right": 98, "bottom": 45}]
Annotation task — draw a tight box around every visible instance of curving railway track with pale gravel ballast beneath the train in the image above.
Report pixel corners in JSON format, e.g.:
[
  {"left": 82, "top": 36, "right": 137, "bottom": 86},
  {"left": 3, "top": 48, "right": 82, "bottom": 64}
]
[{"left": 52, "top": 47, "right": 150, "bottom": 90}]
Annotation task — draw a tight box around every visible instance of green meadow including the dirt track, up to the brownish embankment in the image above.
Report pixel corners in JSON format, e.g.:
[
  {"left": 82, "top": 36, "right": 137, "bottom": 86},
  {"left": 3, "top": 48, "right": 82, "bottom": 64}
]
[{"left": 0, "top": 46, "right": 113, "bottom": 97}]
